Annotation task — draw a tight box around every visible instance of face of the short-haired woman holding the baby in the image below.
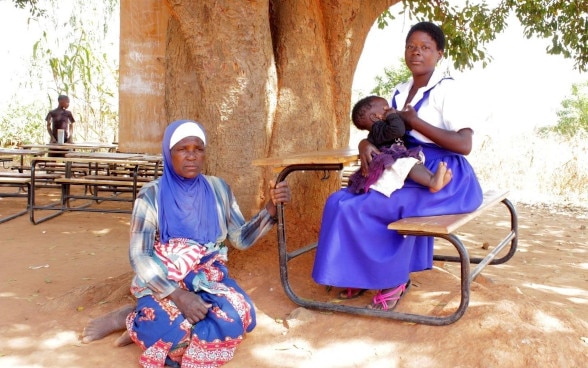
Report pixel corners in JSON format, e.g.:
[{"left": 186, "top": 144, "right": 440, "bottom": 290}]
[{"left": 404, "top": 31, "right": 443, "bottom": 76}]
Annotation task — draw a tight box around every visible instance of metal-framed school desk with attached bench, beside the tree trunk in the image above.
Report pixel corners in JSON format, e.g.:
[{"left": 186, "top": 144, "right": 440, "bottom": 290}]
[{"left": 253, "top": 148, "right": 518, "bottom": 325}]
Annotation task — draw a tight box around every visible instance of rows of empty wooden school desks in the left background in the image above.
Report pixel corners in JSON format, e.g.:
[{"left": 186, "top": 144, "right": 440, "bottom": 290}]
[{"left": 0, "top": 145, "right": 162, "bottom": 224}]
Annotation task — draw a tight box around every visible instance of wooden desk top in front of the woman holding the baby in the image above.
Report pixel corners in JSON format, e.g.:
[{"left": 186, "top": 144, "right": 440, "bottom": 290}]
[{"left": 253, "top": 147, "right": 359, "bottom": 167}]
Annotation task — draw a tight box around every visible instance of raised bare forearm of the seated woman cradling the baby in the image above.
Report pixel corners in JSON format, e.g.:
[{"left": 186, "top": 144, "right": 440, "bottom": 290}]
[{"left": 398, "top": 105, "right": 474, "bottom": 155}]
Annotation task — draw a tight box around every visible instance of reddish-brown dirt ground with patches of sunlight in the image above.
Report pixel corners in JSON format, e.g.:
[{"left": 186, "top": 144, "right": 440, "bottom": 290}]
[{"left": 0, "top": 190, "right": 588, "bottom": 368}]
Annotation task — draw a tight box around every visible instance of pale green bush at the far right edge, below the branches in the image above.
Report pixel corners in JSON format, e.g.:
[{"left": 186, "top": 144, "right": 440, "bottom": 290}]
[{"left": 539, "top": 81, "right": 588, "bottom": 137}]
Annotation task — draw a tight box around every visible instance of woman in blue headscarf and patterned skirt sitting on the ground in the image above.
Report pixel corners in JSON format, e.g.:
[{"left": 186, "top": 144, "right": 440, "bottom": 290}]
[{"left": 83, "top": 120, "right": 290, "bottom": 367}]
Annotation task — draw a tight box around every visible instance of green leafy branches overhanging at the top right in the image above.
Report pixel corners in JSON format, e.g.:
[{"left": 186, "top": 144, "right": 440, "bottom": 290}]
[{"left": 378, "top": 0, "right": 588, "bottom": 71}]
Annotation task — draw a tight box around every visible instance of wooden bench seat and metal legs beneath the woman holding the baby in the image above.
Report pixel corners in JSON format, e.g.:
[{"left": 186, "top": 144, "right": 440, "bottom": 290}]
[{"left": 388, "top": 191, "right": 518, "bottom": 325}]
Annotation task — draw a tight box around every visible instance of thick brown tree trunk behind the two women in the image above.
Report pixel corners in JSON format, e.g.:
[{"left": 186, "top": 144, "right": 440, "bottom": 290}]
[{"left": 120, "top": 0, "right": 398, "bottom": 247}]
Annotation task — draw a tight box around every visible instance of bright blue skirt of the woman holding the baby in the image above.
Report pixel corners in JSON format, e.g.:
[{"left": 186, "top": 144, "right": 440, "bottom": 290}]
[{"left": 312, "top": 139, "right": 483, "bottom": 289}]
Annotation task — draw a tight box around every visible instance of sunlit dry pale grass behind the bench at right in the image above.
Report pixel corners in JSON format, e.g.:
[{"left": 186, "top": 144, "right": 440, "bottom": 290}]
[{"left": 468, "top": 132, "right": 588, "bottom": 211}]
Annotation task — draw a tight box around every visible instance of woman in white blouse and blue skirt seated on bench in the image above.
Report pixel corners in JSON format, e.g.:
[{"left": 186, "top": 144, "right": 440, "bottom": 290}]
[{"left": 312, "top": 22, "right": 482, "bottom": 310}]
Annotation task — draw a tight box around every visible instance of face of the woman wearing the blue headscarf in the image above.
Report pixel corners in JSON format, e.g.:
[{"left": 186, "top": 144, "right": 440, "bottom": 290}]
[{"left": 171, "top": 137, "right": 206, "bottom": 179}]
